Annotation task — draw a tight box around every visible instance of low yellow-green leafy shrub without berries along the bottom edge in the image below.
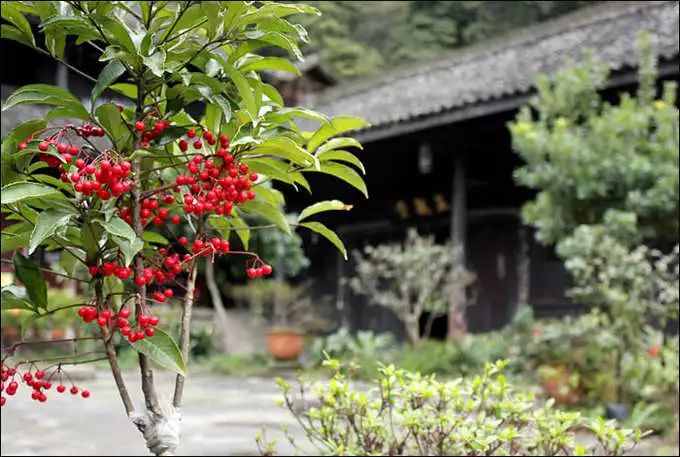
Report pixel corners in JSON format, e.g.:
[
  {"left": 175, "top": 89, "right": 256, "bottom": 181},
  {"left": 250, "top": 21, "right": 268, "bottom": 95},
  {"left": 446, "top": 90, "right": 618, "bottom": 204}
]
[{"left": 256, "top": 359, "right": 645, "bottom": 455}]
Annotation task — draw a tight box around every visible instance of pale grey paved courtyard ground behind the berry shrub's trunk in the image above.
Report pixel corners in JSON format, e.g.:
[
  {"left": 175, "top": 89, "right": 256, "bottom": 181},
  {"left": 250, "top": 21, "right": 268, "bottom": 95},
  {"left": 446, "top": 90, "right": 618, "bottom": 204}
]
[{"left": 1, "top": 372, "right": 301, "bottom": 455}]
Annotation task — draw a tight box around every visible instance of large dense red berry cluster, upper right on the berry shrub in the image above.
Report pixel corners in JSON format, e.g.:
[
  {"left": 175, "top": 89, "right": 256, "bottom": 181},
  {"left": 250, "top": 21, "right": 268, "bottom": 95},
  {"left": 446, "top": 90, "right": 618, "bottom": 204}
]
[{"left": 176, "top": 129, "right": 258, "bottom": 216}]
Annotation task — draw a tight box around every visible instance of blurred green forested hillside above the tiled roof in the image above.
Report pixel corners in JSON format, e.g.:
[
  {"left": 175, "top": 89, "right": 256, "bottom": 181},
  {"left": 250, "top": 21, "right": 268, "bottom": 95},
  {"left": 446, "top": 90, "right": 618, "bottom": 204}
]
[{"left": 298, "top": 1, "right": 595, "bottom": 79}]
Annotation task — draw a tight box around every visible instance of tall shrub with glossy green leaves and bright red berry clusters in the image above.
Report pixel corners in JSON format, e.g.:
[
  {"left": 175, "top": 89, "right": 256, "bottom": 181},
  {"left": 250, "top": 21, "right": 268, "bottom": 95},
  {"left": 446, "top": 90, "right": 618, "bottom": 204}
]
[{"left": 1, "top": 1, "right": 367, "bottom": 455}]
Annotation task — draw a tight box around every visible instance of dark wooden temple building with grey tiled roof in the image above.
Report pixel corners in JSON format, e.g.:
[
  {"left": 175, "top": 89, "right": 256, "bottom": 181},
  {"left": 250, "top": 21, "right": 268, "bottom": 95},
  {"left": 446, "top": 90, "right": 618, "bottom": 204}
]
[{"left": 289, "top": 2, "right": 678, "bottom": 335}]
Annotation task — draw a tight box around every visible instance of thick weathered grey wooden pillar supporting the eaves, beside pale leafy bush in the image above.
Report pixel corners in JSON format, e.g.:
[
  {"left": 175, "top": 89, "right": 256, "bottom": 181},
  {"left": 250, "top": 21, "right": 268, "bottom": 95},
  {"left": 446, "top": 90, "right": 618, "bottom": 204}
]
[{"left": 447, "top": 153, "right": 467, "bottom": 340}]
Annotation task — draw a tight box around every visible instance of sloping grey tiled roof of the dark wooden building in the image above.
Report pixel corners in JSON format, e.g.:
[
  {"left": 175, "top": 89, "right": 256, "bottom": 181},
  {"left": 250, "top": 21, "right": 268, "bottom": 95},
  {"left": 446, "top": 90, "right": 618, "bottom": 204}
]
[{"left": 314, "top": 1, "right": 678, "bottom": 135}]
